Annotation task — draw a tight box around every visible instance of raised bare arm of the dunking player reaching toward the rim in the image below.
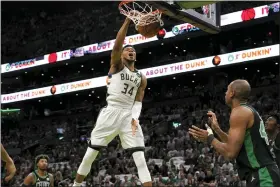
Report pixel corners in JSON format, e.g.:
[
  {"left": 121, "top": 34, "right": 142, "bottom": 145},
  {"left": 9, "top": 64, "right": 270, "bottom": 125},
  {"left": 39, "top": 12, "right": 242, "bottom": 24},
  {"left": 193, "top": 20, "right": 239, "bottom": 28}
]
[{"left": 111, "top": 18, "right": 131, "bottom": 70}]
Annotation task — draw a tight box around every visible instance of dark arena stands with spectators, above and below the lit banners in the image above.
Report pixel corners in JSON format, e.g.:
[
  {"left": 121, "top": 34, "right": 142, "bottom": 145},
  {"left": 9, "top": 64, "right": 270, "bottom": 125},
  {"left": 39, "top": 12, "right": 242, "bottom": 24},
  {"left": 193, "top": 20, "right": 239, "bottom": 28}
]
[{"left": 1, "top": 2, "right": 280, "bottom": 187}]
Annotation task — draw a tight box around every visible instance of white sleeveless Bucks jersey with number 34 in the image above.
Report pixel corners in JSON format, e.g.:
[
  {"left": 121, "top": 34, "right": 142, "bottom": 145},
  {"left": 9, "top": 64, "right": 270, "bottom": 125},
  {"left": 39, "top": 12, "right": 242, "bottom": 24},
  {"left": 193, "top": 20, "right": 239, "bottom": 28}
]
[{"left": 106, "top": 66, "right": 141, "bottom": 109}]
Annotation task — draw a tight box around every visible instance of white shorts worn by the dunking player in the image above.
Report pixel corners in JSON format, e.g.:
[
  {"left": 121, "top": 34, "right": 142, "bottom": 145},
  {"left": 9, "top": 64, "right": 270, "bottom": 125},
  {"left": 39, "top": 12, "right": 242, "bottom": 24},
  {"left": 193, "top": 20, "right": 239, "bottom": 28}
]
[{"left": 90, "top": 106, "right": 145, "bottom": 149}]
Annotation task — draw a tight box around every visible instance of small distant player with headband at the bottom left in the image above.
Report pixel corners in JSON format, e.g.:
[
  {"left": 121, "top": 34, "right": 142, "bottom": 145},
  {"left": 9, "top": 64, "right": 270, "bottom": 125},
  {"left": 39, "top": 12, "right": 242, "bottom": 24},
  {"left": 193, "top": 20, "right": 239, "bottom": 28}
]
[{"left": 22, "top": 155, "right": 54, "bottom": 187}]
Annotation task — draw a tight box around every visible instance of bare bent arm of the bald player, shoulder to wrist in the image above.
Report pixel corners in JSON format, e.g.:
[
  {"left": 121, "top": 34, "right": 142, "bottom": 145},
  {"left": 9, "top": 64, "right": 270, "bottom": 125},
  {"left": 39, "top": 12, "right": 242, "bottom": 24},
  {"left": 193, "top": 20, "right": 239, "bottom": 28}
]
[{"left": 211, "top": 107, "right": 248, "bottom": 159}]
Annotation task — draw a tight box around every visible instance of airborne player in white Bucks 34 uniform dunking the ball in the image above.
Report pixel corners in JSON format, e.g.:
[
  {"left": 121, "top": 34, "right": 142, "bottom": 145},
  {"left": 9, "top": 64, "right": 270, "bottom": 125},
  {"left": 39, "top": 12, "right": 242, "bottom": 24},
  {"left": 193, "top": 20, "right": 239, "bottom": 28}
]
[{"left": 73, "top": 18, "right": 152, "bottom": 187}]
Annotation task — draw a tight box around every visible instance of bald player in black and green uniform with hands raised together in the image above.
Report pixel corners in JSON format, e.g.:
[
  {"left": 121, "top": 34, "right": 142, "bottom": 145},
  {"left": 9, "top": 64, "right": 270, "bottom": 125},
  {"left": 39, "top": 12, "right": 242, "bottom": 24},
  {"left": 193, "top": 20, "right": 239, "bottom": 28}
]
[{"left": 189, "top": 80, "right": 280, "bottom": 187}]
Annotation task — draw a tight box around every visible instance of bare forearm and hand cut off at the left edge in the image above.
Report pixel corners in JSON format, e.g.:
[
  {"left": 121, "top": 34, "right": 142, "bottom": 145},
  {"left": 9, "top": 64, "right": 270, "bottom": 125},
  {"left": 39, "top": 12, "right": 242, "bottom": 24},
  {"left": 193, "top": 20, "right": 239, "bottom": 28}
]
[{"left": 1, "top": 144, "right": 16, "bottom": 182}]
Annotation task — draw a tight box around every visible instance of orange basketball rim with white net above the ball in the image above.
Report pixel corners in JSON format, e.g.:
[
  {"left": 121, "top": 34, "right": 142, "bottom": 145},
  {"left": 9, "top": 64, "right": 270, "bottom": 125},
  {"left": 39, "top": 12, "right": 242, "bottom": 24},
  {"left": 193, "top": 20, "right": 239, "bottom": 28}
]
[{"left": 119, "top": 1, "right": 164, "bottom": 28}]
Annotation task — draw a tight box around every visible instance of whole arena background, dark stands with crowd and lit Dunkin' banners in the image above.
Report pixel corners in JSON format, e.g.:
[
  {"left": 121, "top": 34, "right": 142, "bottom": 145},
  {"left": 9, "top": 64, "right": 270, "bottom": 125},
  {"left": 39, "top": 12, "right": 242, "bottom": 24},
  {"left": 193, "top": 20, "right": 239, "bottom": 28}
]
[{"left": 1, "top": 2, "right": 280, "bottom": 187}]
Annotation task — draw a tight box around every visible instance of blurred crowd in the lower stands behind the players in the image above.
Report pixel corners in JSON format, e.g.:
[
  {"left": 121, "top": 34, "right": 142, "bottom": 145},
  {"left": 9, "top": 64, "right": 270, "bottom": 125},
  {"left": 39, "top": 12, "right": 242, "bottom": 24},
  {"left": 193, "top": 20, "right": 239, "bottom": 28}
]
[{"left": 1, "top": 67, "right": 280, "bottom": 187}]
